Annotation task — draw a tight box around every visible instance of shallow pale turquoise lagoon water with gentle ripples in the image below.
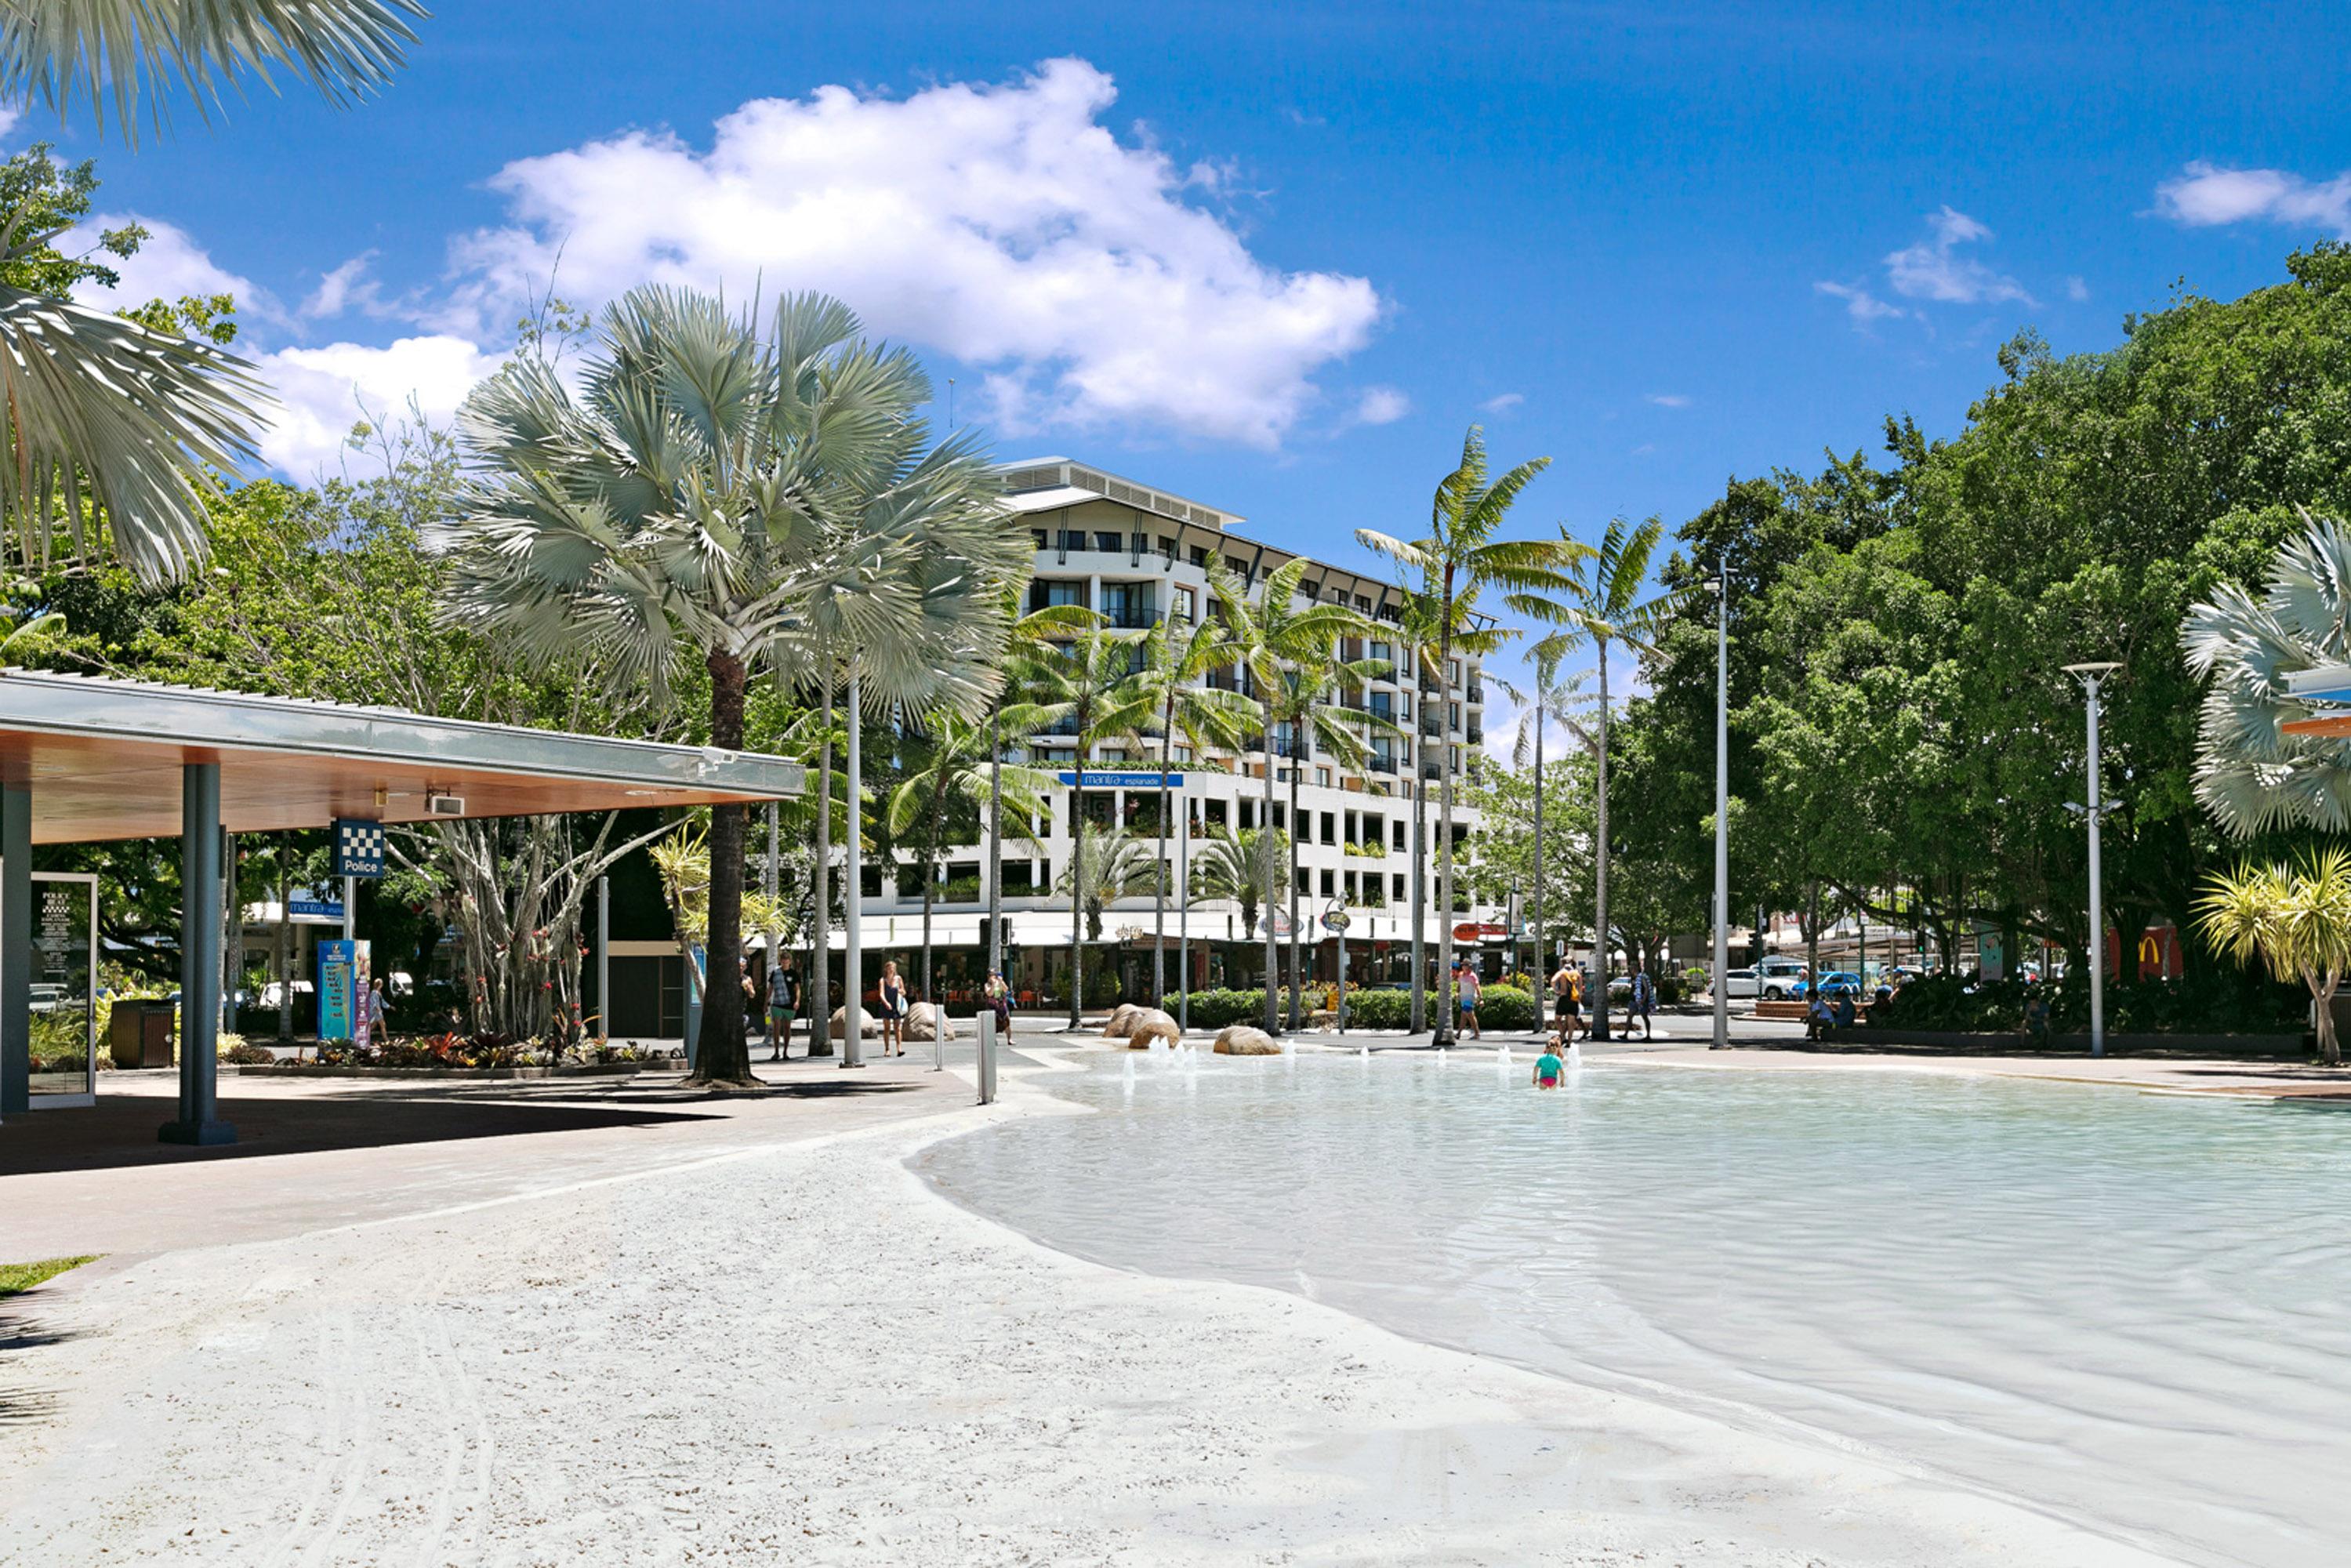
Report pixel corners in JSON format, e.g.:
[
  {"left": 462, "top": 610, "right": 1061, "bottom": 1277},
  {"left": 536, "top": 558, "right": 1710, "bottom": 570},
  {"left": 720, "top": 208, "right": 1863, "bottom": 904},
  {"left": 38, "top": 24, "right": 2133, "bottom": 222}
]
[{"left": 922, "top": 1053, "right": 2351, "bottom": 1563}]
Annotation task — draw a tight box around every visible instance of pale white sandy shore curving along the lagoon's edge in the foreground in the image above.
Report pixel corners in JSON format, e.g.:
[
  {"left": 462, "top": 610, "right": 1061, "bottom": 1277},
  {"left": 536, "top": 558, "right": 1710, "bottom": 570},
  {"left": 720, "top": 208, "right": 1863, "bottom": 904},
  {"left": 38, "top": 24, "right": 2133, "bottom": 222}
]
[{"left": 0, "top": 1072, "right": 2158, "bottom": 1566}]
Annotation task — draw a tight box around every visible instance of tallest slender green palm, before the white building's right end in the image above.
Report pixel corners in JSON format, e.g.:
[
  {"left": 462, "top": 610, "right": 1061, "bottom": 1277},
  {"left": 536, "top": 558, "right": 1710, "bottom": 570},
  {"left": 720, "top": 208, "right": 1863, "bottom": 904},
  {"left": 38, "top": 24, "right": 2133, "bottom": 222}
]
[{"left": 1354, "top": 426, "right": 1566, "bottom": 1041}]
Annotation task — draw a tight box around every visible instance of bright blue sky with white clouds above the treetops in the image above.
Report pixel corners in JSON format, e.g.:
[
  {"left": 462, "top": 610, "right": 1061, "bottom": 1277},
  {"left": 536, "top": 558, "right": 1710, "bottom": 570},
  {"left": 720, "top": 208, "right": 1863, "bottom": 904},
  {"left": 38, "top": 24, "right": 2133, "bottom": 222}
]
[{"left": 45, "top": 0, "right": 2351, "bottom": 695}]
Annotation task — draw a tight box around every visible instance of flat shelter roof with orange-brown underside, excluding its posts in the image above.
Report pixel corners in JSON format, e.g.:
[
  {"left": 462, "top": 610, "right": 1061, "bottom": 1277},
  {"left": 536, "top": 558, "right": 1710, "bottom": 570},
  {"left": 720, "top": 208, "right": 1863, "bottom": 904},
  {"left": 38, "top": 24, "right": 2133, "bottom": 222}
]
[{"left": 0, "top": 670, "right": 802, "bottom": 844}]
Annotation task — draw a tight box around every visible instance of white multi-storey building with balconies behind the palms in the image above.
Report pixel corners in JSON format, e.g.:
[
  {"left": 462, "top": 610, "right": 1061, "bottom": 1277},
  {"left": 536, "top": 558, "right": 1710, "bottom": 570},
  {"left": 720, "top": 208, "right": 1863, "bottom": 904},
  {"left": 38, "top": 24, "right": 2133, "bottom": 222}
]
[{"left": 863, "top": 459, "right": 1486, "bottom": 1006}]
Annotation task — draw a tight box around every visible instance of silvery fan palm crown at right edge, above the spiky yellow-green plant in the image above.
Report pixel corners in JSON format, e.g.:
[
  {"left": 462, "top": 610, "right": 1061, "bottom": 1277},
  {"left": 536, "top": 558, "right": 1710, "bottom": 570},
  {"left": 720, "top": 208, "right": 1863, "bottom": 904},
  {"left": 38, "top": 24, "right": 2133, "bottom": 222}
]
[{"left": 2179, "top": 513, "right": 2351, "bottom": 839}]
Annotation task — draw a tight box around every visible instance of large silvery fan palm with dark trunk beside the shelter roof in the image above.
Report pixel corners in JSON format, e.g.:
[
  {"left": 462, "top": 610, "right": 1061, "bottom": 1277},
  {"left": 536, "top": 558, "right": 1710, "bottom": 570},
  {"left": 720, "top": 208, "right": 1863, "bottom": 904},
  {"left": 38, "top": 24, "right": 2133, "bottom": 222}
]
[{"left": 447, "top": 287, "right": 1014, "bottom": 1081}]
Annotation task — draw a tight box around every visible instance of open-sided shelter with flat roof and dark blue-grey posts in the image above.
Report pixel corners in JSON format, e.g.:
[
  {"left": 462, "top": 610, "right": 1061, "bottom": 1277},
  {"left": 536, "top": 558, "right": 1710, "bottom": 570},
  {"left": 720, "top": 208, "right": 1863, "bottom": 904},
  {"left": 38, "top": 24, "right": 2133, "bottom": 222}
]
[{"left": 0, "top": 670, "right": 802, "bottom": 1145}]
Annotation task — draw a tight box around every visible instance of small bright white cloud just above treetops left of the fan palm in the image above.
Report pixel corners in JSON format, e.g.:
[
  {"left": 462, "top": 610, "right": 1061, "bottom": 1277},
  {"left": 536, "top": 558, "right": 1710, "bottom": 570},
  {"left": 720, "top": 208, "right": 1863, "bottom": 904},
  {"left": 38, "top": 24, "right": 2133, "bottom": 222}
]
[{"left": 259, "top": 334, "right": 503, "bottom": 480}]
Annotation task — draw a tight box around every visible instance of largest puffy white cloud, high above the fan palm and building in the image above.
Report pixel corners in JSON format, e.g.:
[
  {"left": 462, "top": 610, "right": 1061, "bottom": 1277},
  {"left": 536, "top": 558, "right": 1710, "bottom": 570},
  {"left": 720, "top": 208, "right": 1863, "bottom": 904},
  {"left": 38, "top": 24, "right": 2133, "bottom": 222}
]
[{"left": 433, "top": 59, "right": 1380, "bottom": 447}]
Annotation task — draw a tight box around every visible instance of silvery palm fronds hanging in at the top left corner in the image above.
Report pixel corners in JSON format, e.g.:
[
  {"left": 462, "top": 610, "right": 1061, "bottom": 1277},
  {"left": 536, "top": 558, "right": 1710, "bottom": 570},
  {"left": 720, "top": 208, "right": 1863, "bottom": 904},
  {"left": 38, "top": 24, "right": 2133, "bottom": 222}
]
[{"left": 0, "top": 0, "right": 426, "bottom": 586}]
